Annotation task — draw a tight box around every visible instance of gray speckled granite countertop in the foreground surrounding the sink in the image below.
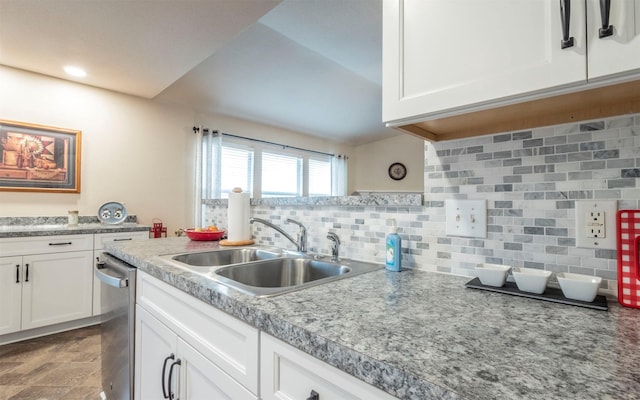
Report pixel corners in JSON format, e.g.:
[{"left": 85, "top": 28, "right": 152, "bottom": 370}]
[{"left": 106, "top": 238, "right": 640, "bottom": 399}]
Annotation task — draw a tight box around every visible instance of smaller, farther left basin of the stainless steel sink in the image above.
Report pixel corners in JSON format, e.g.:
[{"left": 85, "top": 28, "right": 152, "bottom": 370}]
[{"left": 171, "top": 247, "right": 282, "bottom": 267}]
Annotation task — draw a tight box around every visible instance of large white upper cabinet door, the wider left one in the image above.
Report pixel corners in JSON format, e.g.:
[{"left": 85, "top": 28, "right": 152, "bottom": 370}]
[{"left": 383, "top": 0, "right": 587, "bottom": 121}]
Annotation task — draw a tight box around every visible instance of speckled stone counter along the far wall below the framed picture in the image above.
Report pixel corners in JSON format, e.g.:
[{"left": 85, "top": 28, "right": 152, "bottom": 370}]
[{"left": 0, "top": 215, "right": 149, "bottom": 238}]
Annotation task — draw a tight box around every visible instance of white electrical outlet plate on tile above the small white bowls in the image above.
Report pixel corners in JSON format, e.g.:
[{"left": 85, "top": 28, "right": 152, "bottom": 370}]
[{"left": 576, "top": 200, "right": 618, "bottom": 249}]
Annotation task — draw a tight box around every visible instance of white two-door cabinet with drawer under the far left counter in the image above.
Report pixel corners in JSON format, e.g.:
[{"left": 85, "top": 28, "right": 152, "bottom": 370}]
[{"left": 0, "top": 235, "right": 93, "bottom": 335}]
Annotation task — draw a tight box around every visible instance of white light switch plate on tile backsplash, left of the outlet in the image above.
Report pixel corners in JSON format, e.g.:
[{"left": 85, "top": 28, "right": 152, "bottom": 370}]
[{"left": 444, "top": 200, "right": 487, "bottom": 238}]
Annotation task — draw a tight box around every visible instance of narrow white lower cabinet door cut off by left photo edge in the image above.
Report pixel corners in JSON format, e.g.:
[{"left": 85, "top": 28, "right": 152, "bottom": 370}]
[{"left": 0, "top": 257, "right": 23, "bottom": 335}]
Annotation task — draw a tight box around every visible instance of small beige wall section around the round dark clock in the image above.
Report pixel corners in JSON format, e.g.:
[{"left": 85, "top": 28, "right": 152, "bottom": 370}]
[{"left": 352, "top": 134, "right": 424, "bottom": 192}]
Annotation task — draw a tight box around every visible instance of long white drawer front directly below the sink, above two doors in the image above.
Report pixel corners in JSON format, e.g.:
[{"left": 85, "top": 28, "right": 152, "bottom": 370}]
[{"left": 136, "top": 271, "right": 259, "bottom": 394}]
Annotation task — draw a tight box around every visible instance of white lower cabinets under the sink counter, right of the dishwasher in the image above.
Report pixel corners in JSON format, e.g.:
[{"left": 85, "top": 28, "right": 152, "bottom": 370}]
[{"left": 134, "top": 271, "right": 396, "bottom": 400}]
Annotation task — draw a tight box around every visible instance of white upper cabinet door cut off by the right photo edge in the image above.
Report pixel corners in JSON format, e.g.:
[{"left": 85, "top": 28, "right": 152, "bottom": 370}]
[{"left": 587, "top": 0, "right": 640, "bottom": 80}]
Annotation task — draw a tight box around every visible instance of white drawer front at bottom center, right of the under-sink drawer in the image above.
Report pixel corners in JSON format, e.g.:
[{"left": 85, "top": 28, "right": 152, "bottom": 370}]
[{"left": 260, "top": 333, "right": 396, "bottom": 400}]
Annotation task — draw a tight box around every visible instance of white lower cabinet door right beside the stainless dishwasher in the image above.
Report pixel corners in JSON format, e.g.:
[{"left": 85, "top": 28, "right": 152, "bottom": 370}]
[{"left": 134, "top": 306, "right": 178, "bottom": 399}]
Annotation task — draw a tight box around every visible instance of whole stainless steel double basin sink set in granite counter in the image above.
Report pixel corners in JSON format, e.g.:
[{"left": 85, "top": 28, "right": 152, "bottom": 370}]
[{"left": 161, "top": 246, "right": 382, "bottom": 297}]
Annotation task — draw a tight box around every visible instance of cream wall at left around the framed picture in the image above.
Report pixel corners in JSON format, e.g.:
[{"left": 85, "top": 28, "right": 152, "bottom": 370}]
[{"left": 0, "top": 67, "right": 195, "bottom": 231}]
